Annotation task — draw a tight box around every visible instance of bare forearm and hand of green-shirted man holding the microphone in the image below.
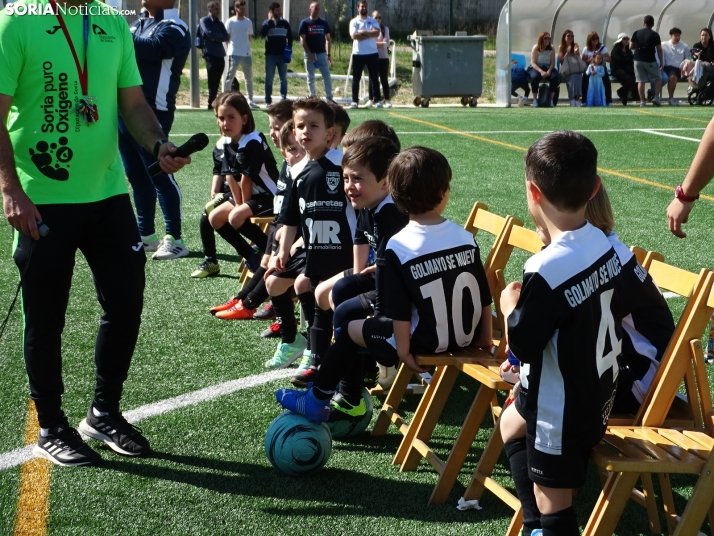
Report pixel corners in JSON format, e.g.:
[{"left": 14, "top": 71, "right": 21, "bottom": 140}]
[{"left": 117, "top": 86, "right": 191, "bottom": 173}]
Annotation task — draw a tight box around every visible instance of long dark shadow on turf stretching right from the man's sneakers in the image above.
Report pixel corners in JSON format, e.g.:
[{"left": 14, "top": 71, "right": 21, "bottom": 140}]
[{"left": 102, "top": 452, "right": 508, "bottom": 523}]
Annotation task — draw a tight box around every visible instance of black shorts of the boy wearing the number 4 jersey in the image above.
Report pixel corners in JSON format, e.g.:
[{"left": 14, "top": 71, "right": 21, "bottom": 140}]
[{"left": 516, "top": 391, "right": 595, "bottom": 489}]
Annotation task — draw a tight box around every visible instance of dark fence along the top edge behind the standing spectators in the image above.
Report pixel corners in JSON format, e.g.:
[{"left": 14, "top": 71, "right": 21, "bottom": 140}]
[{"left": 122, "top": 0, "right": 503, "bottom": 39}]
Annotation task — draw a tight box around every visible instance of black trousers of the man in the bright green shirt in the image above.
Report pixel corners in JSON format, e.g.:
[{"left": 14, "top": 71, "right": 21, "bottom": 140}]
[{"left": 13, "top": 194, "right": 146, "bottom": 428}]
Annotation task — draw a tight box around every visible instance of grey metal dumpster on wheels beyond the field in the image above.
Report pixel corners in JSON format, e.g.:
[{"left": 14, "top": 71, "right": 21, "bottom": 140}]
[{"left": 409, "top": 34, "right": 486, "bottom": 108}]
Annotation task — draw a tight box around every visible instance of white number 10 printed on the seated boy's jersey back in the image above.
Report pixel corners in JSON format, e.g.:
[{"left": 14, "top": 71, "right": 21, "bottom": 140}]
[{"left": 420, "top": 272, "right": 481, "bottom": 353}]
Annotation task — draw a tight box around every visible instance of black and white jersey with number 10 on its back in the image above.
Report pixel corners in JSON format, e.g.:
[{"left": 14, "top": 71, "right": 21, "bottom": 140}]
[{"left": 384, "top": 220, "right": 491, "bottom": 353}]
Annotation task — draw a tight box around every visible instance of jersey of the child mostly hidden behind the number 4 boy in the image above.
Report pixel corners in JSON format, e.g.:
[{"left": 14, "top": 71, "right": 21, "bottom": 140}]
[{"left": 608, "top": 233, "right": 674, "bottom": 403}]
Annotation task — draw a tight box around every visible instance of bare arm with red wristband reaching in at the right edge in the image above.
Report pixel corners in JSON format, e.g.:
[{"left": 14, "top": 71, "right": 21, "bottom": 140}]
[{"left": 667, "top": 119, "right": 714, "bottom": 238}]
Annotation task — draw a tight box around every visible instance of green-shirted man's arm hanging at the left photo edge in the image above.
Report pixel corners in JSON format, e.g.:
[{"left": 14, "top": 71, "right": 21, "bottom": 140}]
[{"left": 0, "top": 90, "right": 42, "bottom": 240}]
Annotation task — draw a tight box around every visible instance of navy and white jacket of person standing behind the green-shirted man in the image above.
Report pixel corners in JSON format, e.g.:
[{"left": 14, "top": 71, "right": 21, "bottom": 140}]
[{"left": 130, "top": 9, "right": 191, "bottom": 111}]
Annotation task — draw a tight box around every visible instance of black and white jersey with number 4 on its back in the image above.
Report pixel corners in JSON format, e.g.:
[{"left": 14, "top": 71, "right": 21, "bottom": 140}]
[{"left": 508, "top": 223, "right": 625, "bottom": 455}]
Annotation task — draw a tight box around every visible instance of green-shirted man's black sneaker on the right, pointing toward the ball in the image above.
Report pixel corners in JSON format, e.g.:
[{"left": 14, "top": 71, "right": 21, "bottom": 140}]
[{"left": 79, "top": 406, "right": 151, "bottom": 456}]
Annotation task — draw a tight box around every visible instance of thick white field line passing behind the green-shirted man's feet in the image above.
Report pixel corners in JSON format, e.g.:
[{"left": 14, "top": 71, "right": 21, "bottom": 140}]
[{"left": 0, "top": 369, "right": 295, "bottom": 471}]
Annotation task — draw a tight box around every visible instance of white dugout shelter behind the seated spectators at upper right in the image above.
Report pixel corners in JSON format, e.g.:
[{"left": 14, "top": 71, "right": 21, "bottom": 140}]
[{"left": 496, "top": 0, "right": 714, "bottom": 107}]
